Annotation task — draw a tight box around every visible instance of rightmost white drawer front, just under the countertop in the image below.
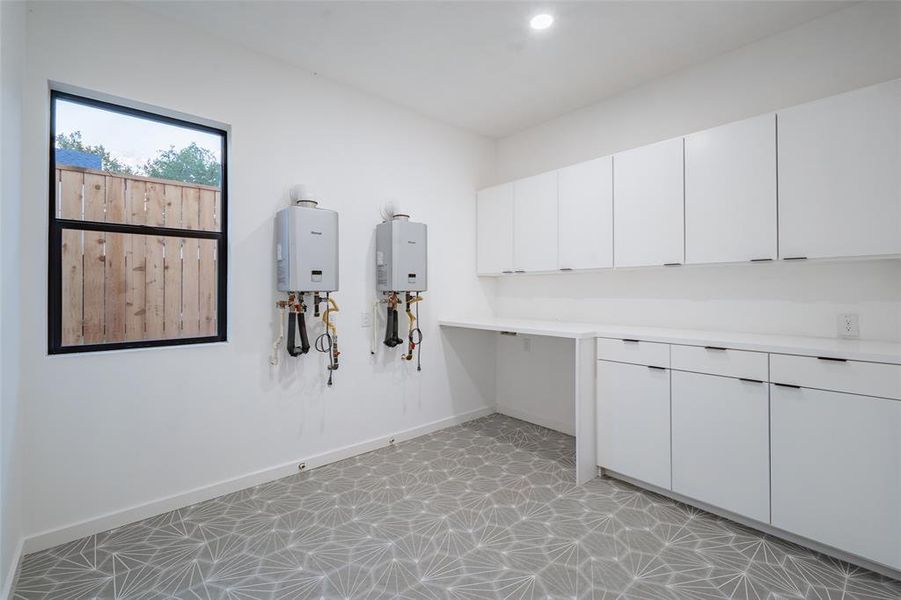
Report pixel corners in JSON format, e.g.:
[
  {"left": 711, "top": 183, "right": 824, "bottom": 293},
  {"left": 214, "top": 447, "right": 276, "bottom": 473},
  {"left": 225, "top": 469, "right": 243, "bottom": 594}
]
[{"left": 770, "top": 354, "right": 901, "bottom": 400}]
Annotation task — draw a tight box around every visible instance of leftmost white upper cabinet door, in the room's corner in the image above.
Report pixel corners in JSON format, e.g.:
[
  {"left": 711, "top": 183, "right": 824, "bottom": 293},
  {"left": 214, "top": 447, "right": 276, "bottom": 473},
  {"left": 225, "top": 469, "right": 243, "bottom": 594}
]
[{"left": 476, "top": 183, "right": 513, "bottom": 275}]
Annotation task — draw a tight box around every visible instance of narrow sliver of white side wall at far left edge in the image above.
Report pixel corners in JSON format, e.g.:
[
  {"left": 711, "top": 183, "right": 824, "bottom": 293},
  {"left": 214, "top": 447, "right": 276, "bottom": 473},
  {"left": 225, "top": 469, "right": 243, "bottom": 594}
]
[{"left": 0, "top": 2, "right": 25, "bottom": 598}]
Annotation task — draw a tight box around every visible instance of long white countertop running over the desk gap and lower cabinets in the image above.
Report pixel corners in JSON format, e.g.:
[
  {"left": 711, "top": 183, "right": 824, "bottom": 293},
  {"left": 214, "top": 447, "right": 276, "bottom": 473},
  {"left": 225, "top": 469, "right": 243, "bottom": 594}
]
[{"left": 439, "top": 317, "right": 901, "bottom": 364}]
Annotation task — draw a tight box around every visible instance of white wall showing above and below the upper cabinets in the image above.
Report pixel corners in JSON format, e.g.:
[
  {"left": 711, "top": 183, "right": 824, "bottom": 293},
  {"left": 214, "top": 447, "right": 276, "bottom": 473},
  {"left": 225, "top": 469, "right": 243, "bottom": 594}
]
[{"left": 495, "top": 2, "right": 901, "bottom": 340}]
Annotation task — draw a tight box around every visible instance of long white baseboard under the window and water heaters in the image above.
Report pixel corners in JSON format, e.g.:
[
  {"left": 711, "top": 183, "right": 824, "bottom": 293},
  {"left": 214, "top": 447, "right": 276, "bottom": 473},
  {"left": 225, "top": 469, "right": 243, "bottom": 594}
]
[{"left": 20, "top": 407, "right": 496, "bottom": 554}]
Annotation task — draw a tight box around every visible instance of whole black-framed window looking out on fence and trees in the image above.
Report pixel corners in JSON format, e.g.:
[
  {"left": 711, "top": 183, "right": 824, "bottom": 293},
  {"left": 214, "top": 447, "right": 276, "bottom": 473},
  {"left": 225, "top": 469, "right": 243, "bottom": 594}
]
[{"left": 48, "top": 91, "right": 228, "bottom": 354}]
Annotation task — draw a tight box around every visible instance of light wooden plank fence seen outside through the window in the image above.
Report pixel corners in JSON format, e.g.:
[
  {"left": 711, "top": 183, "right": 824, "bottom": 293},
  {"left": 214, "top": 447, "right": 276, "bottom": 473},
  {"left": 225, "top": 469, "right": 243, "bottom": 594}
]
[{"left": 56, "top": 167, "right": 220, "bottom": 346}]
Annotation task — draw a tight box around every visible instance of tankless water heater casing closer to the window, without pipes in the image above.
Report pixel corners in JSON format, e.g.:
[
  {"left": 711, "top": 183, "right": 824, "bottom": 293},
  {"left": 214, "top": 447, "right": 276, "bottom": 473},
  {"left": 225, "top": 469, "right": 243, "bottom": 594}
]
[{"left": 275, "top": 200, "right": 338, "bottom": 292}]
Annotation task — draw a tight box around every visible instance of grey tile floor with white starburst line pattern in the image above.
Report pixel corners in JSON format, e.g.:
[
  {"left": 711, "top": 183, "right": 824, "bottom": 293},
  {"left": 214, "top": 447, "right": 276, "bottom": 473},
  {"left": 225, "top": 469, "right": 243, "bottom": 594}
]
[{"left": 13, "top": 415, "right": 901, "bottom": 600}]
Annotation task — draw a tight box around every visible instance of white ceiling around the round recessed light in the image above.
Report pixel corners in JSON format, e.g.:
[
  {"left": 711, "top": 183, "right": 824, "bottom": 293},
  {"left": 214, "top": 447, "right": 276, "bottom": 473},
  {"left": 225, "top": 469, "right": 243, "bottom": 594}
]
[{"left": 139, "top": 0, "right": 848, "bottom": 137}]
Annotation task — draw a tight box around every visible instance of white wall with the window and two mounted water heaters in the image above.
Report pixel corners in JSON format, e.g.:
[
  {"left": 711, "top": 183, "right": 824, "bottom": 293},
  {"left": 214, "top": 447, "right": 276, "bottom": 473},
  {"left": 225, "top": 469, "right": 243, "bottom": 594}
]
[{"left": 21, "top": 3, "right": 494, "bottom": 549}]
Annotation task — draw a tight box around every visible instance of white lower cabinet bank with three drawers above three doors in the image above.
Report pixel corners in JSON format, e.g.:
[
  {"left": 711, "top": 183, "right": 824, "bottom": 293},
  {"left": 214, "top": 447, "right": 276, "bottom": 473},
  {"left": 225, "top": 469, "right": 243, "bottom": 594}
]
[{"left": 597, "top": 338, "right": 901, "bottom": 571}]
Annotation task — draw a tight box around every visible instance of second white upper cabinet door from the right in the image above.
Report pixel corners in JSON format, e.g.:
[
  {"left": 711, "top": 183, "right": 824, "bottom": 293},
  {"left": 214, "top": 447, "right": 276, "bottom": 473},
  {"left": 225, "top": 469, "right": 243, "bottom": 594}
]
[{"left": 685, "top": 114, "right": 776, "bottom": 263}]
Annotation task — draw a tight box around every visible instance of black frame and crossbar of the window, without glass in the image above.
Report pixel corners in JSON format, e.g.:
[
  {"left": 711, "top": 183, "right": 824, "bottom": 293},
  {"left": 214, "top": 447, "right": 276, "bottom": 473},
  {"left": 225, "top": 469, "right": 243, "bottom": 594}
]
[{"left": 47, "top": 89, "right": 229, "bottom": 354}]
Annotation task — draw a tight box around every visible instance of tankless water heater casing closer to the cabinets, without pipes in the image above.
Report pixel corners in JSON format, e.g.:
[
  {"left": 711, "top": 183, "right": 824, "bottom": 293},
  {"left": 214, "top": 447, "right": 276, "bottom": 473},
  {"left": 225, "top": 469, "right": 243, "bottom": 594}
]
[{"left": 375, "top": 215, "right": 429, "bottom": 292}]
